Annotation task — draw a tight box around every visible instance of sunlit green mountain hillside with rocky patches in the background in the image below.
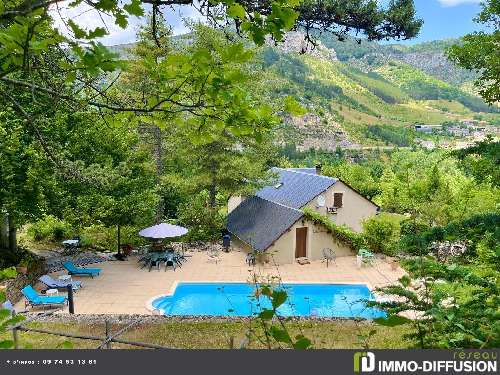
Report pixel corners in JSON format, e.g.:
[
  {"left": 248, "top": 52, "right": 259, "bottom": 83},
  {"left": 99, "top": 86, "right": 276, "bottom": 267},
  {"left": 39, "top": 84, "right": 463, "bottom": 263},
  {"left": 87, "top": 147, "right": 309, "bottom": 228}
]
[{"left": 112, "top": 32, "right": 500, "bottom": 150}]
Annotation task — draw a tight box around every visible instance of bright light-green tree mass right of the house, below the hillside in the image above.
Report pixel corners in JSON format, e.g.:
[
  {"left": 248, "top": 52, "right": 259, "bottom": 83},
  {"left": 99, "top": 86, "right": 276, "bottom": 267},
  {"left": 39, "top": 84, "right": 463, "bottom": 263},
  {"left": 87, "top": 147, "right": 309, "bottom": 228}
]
[{"left": 375, "top": 151, "right": 500, "bottom": 226}]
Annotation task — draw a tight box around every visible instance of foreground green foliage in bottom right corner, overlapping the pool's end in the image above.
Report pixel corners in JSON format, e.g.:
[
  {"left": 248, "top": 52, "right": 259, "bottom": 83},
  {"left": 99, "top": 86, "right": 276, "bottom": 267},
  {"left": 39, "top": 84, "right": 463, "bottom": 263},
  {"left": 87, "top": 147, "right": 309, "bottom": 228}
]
[{"left": 371, "top": 257, "right": 500, "bottom": 348}]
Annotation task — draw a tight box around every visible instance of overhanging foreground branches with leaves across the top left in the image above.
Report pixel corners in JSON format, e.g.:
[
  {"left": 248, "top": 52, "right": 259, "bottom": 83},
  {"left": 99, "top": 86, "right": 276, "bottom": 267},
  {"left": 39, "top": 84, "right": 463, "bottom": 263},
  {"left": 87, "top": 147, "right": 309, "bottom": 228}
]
[{"left": 0, "top": 0, "right": 422, "bottom": 137}]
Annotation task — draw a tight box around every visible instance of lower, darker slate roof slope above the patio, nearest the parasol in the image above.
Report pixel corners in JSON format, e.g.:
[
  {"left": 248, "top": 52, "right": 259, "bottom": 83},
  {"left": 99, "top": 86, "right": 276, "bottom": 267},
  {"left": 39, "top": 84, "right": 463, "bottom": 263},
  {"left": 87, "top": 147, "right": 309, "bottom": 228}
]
[{"left": 227, "top": 196, "right": 303, "bottom": 251}]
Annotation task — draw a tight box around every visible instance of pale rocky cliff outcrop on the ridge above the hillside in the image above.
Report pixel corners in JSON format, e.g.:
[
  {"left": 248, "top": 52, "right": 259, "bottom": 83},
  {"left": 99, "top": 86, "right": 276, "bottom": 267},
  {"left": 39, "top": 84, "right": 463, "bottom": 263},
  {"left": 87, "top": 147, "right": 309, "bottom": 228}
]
[{"left": 267, "top": 31, "right": 338, "bottom": 61}]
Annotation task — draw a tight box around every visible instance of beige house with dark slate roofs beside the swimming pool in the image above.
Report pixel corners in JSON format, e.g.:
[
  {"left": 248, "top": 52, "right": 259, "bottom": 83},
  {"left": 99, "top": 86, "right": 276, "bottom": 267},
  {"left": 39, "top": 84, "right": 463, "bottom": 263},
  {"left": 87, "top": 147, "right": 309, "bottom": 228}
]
[{"left": 227, "top": 167, "right": 379, "bottom": 264}]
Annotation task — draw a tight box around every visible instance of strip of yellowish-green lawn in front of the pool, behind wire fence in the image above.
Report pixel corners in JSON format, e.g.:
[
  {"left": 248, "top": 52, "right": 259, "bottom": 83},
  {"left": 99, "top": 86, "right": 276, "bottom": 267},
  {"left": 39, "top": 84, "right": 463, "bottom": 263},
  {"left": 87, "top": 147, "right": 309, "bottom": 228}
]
[{"left": 0, "top": 321, "right": 410, "bottom": 349}]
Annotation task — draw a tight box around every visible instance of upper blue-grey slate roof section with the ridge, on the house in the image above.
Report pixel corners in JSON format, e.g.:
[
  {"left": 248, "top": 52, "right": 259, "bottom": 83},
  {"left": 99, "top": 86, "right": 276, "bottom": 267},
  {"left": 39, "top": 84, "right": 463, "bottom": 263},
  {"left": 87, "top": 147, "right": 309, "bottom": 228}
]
[{"left": 255, "top": 168, "right": 338, "bottom": 208}]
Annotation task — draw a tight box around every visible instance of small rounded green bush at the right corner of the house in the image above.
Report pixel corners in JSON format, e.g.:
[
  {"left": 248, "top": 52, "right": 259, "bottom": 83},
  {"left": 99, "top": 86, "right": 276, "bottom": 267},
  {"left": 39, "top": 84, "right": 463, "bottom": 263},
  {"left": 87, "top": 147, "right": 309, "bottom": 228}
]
[{"left": 363, "top": 213, "right": 402, "bottom": 255}]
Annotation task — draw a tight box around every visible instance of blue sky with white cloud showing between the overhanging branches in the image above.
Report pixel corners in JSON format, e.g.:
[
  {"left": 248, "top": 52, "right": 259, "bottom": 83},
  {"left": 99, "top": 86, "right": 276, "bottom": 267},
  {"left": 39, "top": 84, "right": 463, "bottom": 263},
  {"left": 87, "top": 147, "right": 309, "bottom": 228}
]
[{"left": 52, "top": 0, "right": 481, "bottom": 45}]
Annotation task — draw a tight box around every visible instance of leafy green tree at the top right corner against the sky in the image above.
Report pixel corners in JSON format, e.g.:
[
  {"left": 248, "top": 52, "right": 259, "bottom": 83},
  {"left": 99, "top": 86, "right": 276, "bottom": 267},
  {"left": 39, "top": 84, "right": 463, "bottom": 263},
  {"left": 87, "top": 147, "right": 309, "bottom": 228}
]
[{"left": 447, "top": 0, "right": 500, "bottom": 104}]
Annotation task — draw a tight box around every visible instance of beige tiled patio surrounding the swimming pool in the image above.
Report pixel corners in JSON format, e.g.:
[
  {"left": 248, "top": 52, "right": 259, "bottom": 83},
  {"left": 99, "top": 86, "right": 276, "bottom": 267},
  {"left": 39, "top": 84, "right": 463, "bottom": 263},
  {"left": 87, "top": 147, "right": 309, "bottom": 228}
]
[{"left": 19, "top": 251, "right": 404, "bottom": 314}]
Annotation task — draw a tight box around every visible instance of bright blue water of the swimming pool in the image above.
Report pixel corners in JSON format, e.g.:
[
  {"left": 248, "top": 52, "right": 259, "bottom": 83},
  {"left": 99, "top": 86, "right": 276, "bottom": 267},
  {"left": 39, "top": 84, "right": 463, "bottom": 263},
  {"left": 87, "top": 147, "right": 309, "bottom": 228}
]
[{"left": 152, "top": 283, "right": 385, "bottom": 319}]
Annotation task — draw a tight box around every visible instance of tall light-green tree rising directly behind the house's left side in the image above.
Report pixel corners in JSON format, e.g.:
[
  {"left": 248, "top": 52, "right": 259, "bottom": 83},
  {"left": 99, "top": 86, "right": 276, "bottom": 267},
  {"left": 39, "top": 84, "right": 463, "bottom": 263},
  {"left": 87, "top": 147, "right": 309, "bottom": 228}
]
[{"left": 116, "top": 22, "right": 280, "bottom": 217}]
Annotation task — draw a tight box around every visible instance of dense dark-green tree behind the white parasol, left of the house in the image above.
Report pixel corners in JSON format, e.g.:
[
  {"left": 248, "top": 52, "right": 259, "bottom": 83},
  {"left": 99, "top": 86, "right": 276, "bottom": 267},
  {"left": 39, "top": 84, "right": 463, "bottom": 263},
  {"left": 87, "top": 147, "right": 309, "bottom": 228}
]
[{"left": 51, "top": 112, "right": 158, "bottom": 251}]
